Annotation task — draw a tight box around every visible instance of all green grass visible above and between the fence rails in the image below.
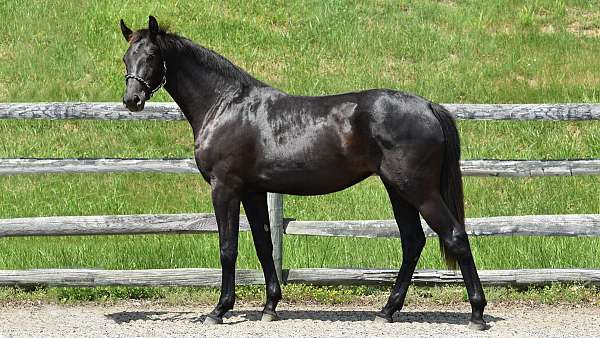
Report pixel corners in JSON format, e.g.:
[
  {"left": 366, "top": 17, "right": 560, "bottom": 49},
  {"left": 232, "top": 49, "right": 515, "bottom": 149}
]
[{"left": 0, "top": 0, "right": 600, "bottom": 298}]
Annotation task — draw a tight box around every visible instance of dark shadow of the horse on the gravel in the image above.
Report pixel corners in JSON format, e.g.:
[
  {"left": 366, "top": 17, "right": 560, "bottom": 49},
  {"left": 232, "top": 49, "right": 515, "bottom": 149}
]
[{"left": 105, "top": 310, "right": 504, "bottom": 325}]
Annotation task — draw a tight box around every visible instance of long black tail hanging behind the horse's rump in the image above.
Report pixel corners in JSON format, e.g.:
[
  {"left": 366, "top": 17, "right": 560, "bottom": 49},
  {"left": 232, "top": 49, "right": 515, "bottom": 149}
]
[{"left": 429, "top": 103, "right": 465, "bottom": 270}]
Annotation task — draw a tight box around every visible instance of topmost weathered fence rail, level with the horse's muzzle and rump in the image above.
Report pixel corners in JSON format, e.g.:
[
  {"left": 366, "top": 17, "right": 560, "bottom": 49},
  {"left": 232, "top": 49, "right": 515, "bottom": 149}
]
[{"left": 0, "top": 102, "right": 600, "bottom": 121}]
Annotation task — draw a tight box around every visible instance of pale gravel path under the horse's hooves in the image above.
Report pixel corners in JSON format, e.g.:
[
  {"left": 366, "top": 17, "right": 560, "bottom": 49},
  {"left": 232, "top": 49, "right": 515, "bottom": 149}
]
[{"left": 0, "top": 303, "right": 600, "bottom": 338}]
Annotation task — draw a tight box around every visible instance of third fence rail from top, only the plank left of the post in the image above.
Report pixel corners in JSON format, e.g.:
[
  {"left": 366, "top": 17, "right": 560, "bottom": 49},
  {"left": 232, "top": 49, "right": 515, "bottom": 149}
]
[{"left": 0, "top": 214, "right": 250, "bottom": 237}]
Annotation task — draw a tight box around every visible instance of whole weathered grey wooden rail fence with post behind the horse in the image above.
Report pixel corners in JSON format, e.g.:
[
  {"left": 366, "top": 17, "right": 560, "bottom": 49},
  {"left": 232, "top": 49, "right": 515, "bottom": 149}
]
[{"left": 0, "top": 103, "right": 600, "bottom": 286}]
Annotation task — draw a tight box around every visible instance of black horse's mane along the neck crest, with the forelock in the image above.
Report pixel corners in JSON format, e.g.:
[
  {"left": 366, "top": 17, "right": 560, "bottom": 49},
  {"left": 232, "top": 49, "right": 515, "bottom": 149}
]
[{"left": 132, "top": 27, "right": 268, "bottom": 87}]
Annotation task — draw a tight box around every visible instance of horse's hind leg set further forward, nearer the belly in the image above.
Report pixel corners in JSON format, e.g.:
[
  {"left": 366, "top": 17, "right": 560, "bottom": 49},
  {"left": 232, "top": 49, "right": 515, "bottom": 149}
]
[{"left": 375, "top": 181, "right": 425, "bottom": 323}]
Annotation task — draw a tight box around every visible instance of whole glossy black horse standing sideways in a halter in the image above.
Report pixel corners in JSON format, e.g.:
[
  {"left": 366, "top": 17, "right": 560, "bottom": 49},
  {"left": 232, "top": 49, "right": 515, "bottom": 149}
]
[{"left": 121, "top": 16, "right": 486, "bottom": 329}]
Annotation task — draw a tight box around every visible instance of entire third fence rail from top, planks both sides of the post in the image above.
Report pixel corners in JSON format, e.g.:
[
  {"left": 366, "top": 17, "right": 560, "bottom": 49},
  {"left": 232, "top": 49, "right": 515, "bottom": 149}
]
[{"left": 0, "top": 214, "right": 600, "bottom": 238}]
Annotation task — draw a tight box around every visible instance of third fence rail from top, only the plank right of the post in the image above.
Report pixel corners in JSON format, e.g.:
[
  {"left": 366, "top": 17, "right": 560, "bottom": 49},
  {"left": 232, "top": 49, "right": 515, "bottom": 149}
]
[{"left": 285, "top": 214, "right": 600, "bottom": 238}]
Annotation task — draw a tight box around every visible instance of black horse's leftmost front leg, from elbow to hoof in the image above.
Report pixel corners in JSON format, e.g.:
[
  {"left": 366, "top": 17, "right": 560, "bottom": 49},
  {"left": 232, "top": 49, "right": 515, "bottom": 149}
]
[{"left": 204, "top": 180, "right": 240, "bottom": 324}]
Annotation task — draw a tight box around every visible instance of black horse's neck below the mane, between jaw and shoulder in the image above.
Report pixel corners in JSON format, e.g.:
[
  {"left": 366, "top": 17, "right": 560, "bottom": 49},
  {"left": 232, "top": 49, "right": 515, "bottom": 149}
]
[{"left": 165, "top": 55, "right": 242, "bottom": 134}]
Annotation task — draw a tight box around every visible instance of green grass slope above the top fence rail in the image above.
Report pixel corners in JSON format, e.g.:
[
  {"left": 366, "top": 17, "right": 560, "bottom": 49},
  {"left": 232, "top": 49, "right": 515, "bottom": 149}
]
[{"left": 0, "top": 0, "right": 600, "bottom": 103}]
